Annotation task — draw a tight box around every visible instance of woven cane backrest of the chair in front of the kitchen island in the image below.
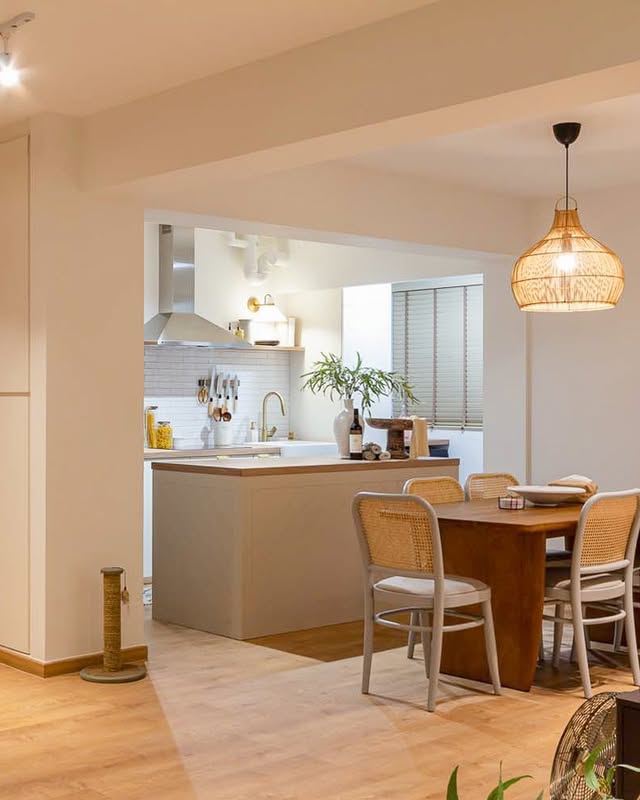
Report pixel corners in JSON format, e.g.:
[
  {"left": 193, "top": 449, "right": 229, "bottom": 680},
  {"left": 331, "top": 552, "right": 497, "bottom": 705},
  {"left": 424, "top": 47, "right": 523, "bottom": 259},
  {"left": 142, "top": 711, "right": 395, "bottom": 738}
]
[{"left": 353, "top": 492, "right": 443, "bottom": 577}]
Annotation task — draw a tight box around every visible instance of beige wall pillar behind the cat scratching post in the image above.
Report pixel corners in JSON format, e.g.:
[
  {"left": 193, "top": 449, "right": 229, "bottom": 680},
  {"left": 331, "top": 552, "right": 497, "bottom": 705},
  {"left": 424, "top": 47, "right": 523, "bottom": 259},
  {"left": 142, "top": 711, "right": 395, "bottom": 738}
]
[{"left": 31, "top": 116, "right": 144, "bottom": 661}]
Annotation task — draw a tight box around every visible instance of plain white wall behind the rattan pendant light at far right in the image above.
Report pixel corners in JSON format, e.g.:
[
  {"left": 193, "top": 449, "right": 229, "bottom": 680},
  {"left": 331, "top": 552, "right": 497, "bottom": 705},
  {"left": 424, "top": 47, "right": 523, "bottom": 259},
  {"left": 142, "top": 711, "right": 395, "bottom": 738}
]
[{"left": 530, "top": 186, "right": 640, "bottom": 489}]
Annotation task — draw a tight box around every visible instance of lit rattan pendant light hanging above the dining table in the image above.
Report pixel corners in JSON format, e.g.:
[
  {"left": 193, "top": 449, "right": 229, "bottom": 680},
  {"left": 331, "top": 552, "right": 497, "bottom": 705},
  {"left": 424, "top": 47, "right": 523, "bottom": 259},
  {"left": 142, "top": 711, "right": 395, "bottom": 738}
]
[{"left": 511, "top": 122, "right": 624, "bottom": 311}]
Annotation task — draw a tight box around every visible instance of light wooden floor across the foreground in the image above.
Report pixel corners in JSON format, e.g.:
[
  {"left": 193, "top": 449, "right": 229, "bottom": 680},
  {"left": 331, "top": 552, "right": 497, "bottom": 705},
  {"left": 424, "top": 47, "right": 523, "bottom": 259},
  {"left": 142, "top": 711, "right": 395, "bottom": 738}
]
[{"left": 0, "top": 621, "right": 632, "bottom": 800}]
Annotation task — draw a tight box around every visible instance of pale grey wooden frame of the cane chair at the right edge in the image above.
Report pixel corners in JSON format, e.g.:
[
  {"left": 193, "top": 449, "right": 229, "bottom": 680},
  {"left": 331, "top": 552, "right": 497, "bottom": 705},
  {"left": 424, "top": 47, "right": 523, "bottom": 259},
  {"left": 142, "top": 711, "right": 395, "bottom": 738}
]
[{"left": 543, "top": 489, "right": 640, "bottom": 698}]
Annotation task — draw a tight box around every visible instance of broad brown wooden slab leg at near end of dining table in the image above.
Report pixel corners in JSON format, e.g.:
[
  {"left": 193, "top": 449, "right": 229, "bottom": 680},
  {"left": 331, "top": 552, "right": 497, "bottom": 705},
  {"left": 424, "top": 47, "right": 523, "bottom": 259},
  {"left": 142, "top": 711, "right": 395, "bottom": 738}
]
[{"left": 440, "top": 520, "right": 546, "bottom": 691}]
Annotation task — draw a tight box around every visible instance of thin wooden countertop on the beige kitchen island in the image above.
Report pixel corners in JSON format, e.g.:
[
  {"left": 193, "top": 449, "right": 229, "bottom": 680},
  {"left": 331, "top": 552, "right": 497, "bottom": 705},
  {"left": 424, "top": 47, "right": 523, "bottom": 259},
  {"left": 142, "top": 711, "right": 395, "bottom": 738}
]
[{"left": 152, "top": 457, "right": 460, "bottom": 478}]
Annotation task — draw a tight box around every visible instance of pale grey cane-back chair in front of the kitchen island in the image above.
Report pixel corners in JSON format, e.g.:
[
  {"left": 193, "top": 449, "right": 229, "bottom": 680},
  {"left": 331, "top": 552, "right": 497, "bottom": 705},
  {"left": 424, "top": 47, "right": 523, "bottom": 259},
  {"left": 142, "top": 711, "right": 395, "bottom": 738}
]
[{"left": 352, "top": 492, "right": 501, "bottom": 711}]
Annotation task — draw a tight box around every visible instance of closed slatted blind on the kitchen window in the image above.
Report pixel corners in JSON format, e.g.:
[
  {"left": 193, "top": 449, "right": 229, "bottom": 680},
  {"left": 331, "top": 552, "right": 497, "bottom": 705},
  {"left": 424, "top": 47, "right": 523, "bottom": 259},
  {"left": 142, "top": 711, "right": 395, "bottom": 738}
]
[{"left": 392, "top": 284, "right": 482, "bottom": 429}]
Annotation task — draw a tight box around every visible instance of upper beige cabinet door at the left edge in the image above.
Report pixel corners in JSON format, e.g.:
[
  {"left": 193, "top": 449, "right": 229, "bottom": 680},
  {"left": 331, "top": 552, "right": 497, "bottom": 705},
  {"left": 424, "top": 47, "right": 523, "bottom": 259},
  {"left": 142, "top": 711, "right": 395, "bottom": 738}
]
[{"left": 0, "top": 136, "right": 29, "bottom": 394}]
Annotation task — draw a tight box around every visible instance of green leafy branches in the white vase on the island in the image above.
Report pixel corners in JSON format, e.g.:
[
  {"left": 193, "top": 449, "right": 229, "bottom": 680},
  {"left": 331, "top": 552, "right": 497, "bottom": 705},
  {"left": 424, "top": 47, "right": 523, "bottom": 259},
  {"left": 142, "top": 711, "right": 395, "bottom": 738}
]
[{"left": 300, "top": 353, "right": 418, "bottom": 422}]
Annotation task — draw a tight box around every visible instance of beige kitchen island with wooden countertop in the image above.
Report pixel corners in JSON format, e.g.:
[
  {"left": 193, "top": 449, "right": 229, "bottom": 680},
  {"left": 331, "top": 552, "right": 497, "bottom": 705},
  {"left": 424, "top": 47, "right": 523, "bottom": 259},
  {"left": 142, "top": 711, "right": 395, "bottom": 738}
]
[{"left": 153, "top": 458, "right": 459, "bottom": 639}]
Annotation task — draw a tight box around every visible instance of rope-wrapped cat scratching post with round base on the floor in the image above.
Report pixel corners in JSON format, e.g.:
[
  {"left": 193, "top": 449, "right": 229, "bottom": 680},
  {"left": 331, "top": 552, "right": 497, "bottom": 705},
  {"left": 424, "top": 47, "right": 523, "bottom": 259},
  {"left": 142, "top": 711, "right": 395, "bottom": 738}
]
[{"left": 80, "top": 567, "right": 147, "bottom": 683}]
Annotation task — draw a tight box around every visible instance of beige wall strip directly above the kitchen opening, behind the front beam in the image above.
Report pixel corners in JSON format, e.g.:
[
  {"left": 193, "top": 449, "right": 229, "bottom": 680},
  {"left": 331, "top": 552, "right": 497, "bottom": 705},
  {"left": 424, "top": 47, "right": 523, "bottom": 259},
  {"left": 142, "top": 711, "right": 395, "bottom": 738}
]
[{"left": 141, "top": 163, "right": 528, "bottom": 260}]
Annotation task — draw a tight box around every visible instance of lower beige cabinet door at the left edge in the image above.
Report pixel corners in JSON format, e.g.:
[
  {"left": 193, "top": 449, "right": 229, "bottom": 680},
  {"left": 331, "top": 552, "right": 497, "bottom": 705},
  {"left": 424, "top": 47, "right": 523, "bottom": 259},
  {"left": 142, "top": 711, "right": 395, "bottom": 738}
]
[{"left": 0, "top": 397, "right": 30, "bottom": 653}]
